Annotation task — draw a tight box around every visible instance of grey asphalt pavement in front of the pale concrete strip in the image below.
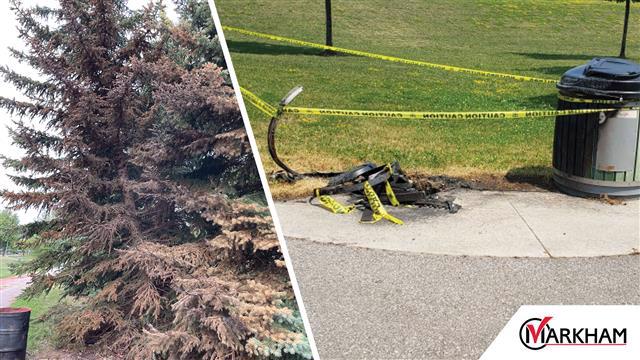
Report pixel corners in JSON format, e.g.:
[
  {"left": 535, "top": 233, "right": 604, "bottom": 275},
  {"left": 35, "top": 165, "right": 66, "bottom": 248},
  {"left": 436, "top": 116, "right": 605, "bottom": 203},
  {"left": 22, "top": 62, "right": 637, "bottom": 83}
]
[{"left": 287, "top": 238, "right": 640, "bottom": 359}]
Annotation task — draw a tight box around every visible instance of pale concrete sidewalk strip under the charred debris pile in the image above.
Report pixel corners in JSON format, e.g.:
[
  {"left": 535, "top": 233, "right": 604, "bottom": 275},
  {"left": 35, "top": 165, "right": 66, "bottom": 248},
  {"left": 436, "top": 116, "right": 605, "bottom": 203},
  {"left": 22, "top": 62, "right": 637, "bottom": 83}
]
[{"left": 276, "top": 190, "right": 640, "bottom": 257}]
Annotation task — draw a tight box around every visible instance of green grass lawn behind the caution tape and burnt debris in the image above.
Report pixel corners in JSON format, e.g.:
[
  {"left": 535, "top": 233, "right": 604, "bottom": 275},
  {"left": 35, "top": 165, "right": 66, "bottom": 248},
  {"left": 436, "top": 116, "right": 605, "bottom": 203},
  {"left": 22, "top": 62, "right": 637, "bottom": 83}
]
[{"left": 216, "top": 0, "right": 640, "bottom": 186}]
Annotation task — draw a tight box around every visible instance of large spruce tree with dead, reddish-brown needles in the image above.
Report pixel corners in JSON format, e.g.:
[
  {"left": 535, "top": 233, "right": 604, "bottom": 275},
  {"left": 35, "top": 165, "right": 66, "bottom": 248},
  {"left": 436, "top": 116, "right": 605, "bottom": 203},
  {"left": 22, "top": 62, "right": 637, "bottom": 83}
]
[{"left": 0, "top": 0, "right": 311, "bottom": 359}]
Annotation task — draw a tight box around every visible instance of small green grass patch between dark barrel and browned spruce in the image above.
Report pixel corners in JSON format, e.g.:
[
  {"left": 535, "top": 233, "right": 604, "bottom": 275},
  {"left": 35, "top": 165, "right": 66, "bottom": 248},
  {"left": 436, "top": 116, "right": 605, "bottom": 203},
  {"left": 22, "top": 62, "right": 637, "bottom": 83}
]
[{"left": 11, "top": 288, "right": 62, "bottom": 353}]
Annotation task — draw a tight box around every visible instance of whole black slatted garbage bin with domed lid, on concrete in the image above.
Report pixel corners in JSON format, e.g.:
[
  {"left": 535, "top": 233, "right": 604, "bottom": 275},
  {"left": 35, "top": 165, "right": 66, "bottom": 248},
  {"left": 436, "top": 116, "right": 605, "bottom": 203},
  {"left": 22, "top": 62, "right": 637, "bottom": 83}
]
[{"left": 553, "top": 58, "right": 640, "bottom": 196}]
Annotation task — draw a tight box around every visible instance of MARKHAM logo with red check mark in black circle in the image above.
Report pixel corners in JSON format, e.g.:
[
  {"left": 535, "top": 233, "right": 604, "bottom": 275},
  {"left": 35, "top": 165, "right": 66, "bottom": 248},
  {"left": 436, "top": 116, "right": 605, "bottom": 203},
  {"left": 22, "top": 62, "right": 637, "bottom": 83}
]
[{"left": 520, "top": 316, "right": 627, "bottom": 350}]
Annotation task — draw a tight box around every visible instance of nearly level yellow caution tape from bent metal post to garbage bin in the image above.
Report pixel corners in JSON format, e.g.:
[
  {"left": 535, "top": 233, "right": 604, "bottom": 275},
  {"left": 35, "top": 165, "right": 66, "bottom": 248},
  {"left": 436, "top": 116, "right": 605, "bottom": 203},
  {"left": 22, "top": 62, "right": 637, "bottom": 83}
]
[{"left": 283, "top": 107, "right": 632, "bottom": 120}]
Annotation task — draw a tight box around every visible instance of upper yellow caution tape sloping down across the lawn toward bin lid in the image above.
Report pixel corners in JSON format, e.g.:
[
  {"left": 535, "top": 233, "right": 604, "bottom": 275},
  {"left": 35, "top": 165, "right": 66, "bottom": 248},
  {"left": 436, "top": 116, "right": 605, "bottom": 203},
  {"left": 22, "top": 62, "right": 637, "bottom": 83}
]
[{"left": 222, "top": 26, "right": 557, "bottom": 84}]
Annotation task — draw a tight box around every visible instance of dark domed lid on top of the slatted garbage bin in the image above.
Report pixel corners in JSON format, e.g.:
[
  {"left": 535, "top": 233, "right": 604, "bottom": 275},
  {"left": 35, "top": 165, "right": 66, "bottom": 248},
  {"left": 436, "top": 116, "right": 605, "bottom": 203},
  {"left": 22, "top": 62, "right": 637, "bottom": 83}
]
[{"left": 557, "top": 58, "right": 640, "bottom": 100}]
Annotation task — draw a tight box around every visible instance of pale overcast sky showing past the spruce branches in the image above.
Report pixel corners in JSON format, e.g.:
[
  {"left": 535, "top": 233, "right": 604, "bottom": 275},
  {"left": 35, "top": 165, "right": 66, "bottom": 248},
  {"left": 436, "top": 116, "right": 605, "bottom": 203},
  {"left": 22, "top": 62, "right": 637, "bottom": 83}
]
[{"left": 0, "top": 0, "right": 177, "bottom": 223}]
